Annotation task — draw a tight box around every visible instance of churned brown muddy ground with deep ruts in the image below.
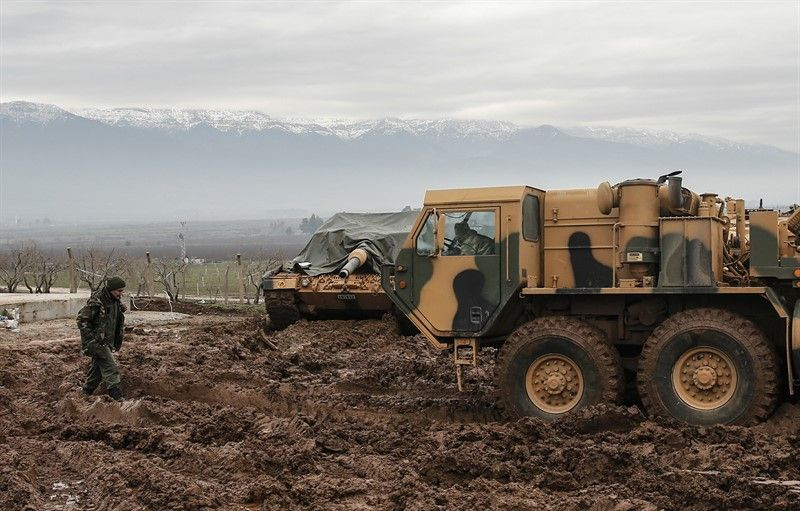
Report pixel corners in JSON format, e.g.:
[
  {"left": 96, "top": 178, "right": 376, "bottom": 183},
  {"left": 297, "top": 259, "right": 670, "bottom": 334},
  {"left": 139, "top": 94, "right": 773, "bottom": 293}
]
[{"left": 0, "top": 309, "right": 800, "bottom": 511}]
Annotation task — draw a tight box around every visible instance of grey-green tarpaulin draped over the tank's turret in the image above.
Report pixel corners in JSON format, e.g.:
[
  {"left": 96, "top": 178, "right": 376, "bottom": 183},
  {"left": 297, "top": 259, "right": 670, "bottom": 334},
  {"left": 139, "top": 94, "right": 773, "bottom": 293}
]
[{"left": 284, "top": 211, "right": 419, "bottom": 275}]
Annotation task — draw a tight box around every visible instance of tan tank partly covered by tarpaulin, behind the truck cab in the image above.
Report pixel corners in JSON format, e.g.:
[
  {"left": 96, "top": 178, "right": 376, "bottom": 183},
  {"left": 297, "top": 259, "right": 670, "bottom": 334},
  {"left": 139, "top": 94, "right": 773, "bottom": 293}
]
[{"left": 261, "top": 211, "right": 418, "bottom": 333}]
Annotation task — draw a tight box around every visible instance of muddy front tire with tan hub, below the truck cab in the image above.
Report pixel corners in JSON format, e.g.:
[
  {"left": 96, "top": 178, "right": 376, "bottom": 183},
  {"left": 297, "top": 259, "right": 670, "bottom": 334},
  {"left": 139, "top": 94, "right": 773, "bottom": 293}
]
[{"left": 495, "top": 316, "right": 624, "bottom": 420}]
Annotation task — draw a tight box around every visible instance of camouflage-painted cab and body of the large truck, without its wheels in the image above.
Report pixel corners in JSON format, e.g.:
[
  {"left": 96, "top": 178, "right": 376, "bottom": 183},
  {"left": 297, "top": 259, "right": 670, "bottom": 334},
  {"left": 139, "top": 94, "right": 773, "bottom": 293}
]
[{"left": 382, "top": 177, "right": 800, "bottom": 396}]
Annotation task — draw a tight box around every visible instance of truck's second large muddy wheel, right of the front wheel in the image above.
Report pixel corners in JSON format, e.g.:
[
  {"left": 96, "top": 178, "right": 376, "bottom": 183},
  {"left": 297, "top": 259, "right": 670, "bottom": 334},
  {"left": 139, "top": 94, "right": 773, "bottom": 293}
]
[{"left": 637, "top": 309, "right": 780, "bottom": 425}]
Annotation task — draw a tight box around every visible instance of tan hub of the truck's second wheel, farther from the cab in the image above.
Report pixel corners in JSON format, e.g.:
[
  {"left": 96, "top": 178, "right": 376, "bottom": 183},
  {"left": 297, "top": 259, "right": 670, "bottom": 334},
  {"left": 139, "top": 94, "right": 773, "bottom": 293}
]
[{"left": 672, "top": 346, "right": 737, "bottom": 410}]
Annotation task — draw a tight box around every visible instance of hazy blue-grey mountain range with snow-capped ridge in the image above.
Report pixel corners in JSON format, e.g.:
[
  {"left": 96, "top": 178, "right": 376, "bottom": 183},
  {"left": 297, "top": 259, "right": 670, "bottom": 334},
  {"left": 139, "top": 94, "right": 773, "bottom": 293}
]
[{"left": 0, "top": 102, "right": 800, "bottom": 223}]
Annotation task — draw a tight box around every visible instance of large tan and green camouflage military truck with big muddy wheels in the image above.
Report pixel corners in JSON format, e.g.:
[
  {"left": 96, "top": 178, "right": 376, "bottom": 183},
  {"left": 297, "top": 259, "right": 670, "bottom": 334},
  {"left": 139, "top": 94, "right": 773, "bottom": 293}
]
[{"left": 382, "top": 173, "right": 800, "bottom": 424}]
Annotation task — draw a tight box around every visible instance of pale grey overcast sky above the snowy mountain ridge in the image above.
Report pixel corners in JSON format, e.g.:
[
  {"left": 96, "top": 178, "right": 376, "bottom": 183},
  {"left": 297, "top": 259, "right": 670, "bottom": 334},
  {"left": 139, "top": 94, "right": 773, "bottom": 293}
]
[{"left": 0, "top": 0, "right": 800, "bottom": 152}]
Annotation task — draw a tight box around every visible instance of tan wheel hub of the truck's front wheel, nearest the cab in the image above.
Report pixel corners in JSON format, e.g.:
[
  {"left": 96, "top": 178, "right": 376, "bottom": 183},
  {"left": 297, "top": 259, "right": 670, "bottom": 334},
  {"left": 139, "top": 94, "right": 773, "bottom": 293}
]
[{"left": 525, "top": 354, "right": 584, "bottom": 413}]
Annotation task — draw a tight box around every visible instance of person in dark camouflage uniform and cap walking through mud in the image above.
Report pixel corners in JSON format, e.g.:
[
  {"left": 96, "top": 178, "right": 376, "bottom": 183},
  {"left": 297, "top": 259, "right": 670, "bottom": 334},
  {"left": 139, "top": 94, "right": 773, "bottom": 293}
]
[{"left": 78, "top": 277, "right": 125, "bottom": 401}]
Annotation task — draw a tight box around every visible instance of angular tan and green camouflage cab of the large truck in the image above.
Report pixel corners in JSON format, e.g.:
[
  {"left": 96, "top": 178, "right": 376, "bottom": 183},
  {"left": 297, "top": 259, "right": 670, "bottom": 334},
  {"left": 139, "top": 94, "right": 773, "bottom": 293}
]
[{"left": 384, "top": 186, "right": 544, "bottom": 347}]
